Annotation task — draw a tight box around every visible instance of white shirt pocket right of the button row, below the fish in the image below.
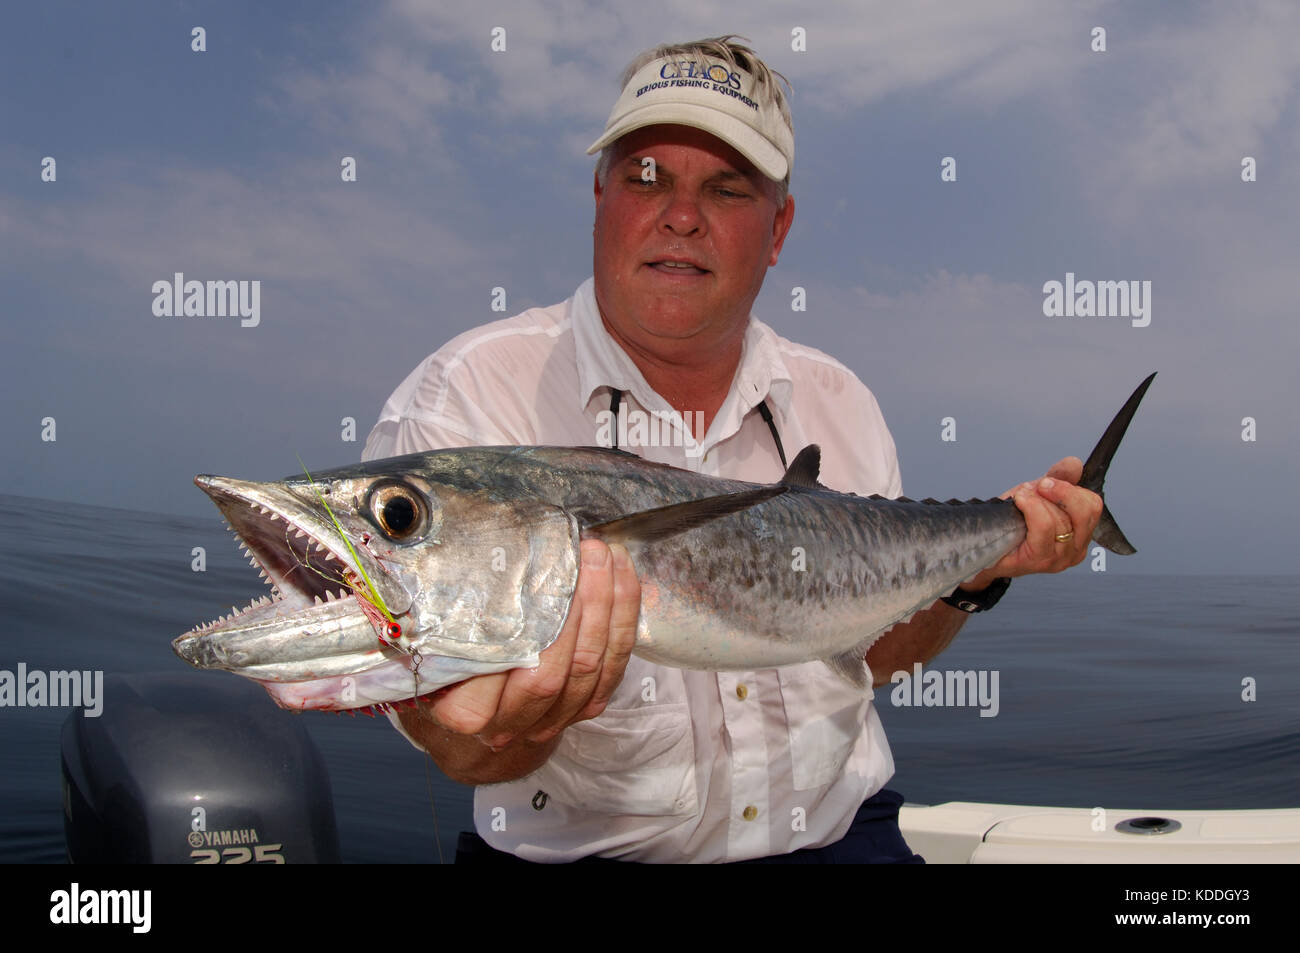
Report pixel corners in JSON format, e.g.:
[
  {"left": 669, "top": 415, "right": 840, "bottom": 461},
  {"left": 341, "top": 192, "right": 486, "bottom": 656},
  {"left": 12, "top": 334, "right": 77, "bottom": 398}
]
[{"left": 776, "top": 662, "right": 874, "bottom": 790}]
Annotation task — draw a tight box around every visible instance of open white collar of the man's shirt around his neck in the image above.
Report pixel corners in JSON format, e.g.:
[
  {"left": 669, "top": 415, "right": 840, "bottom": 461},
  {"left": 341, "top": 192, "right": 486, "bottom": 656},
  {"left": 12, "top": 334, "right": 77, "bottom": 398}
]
[{"left": 569, "top": 278, "right": 793, "bottom": 428}]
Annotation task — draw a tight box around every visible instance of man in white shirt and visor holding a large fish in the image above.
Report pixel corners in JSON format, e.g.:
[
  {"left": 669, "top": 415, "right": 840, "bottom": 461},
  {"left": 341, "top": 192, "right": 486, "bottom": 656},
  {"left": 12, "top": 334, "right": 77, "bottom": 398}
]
[{"left": 365, "top": 38, "right": 1101, "bottom": 862}]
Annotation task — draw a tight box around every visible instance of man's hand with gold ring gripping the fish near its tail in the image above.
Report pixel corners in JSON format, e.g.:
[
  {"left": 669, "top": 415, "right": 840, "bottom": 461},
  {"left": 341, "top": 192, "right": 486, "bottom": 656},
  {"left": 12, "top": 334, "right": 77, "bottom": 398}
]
[{"left": 962, "top": 456, "right": 1101, "bottom": 592}]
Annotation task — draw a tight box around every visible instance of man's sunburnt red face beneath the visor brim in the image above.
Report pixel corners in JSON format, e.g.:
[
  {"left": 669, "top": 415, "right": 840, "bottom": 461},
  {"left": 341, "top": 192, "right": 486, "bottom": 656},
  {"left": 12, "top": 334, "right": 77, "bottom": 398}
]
[{"left": 594, "top": 125, "right": 794, "bottom": 360}]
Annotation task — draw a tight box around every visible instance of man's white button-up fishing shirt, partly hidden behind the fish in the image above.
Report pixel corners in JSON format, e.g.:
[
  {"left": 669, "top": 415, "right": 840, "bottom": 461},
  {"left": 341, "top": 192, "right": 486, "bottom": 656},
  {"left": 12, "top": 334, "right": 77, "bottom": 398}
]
[{"left": 363, "top": 278, "right": 902, "bottom": 862}]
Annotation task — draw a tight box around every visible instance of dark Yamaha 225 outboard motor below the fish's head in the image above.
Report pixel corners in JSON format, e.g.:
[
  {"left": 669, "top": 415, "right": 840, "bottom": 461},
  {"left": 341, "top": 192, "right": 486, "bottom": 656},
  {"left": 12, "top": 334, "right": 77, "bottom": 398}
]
[{"left": 61, "top": 673, "right": 339, "bottom": 863}]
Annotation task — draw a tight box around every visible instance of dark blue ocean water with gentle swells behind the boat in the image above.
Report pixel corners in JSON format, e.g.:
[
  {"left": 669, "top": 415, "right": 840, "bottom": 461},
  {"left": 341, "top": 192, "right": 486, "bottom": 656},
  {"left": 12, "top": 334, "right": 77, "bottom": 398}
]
[{"left": 0, "top": 495, "right": 1300, "bottom": 862}]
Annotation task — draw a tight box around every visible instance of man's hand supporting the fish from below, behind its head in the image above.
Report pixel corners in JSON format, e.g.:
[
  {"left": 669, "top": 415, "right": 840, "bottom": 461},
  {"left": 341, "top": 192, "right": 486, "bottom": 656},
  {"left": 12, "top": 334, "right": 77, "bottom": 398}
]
[{"left": 399, "top": 540, "right": 641, "bottom": 784}]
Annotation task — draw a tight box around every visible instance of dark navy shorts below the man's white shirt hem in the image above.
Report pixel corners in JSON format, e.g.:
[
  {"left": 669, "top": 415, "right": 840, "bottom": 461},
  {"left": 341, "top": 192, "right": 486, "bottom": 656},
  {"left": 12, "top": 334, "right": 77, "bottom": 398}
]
[{"left": 456, "top": 790, "right": 926, "bottom": 865}]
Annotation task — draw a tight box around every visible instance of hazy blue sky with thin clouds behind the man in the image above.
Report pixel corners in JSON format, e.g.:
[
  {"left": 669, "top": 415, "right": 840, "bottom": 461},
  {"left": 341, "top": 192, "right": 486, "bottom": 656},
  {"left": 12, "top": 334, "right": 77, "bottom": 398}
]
[{"left": 0, "top": 0, "right": 1300, "bottom": 573}]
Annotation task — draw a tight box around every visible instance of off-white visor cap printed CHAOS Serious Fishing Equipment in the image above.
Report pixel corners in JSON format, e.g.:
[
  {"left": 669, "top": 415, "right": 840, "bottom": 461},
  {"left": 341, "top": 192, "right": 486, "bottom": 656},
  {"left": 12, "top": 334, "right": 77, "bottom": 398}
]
[{"left": 586, "top": 55, "right": 794, "bottom": 182}]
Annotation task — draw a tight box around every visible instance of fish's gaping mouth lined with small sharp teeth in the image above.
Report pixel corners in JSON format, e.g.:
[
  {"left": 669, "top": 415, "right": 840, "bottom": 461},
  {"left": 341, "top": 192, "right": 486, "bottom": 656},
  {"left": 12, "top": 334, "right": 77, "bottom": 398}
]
[{"left": 172, "top": 475, "right": 410, "bottom": 680}]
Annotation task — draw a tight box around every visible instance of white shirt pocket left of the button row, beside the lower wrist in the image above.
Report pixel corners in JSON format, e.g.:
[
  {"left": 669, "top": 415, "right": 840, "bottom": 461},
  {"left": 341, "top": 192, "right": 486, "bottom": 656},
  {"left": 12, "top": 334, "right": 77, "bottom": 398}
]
[{"left": 534, "top": 702, "right": 699, "bottom": 816}]
